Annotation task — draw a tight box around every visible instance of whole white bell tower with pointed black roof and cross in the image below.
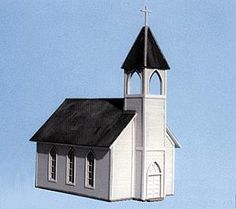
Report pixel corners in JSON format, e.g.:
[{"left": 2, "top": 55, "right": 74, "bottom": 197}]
[{"left": 121, "top": 7, "right": 169, "bottom": 200}]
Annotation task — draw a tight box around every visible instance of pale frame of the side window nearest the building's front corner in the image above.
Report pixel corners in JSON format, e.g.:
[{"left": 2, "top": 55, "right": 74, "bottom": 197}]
[{"left": 85, "top": 150, "right": 96, "bottom": 189}]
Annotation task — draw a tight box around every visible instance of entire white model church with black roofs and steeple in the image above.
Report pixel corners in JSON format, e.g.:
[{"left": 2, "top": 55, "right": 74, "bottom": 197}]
[{"left": 30, "top": 10, "right": 180, "bottom": 201}]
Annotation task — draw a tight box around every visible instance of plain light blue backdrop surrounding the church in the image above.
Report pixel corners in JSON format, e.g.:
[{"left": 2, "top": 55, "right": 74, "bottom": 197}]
[{"left": 0, "top": 0, "right": 236, "bottom": 209}]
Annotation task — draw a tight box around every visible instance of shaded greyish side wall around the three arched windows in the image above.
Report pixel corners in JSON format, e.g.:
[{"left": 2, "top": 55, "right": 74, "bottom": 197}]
[{"left": 36, "top": 143, "right": 110, "bottom": 200}]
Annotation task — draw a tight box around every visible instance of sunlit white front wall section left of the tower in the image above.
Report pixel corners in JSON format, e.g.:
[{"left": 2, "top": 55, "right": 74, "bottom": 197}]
[{"left": 110, "top": 121, "right": 134, "bottom": 200}]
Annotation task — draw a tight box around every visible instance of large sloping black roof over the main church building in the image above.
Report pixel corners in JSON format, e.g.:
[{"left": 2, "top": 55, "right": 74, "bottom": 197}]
[{"left": 30, "top": 99, "right": 135, "bottom": 147}]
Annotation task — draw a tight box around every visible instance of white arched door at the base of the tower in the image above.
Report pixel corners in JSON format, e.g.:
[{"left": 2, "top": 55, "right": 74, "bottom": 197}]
[{"left": 147, "top": 162, "right": 161, "bottom": 199}]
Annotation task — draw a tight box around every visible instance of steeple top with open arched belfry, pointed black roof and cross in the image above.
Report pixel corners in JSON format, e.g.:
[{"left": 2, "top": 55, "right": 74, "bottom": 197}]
[{"left": 121, "top": 7, "right": 170, "bottom": 97}]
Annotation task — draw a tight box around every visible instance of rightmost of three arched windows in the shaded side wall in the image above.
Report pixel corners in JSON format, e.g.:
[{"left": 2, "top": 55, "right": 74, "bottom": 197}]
[{"left": 85, "top": 151, "right": 95, "bottom": 188}]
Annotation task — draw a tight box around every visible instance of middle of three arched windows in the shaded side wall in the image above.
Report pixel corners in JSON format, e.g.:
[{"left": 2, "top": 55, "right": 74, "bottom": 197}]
[{"left": 67, "top": 149, "right": 75, "bottom": 184}]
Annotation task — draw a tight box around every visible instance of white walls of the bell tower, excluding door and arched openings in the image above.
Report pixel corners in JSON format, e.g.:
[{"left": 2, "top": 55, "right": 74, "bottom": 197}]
[{"left": 122, "top": 69, "right": 169, "bottom": 200}]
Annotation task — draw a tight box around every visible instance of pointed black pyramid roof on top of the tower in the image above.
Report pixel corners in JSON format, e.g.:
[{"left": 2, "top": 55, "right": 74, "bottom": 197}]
[{"left": 121, "top": 26, "right": 170, "bottom": 72}]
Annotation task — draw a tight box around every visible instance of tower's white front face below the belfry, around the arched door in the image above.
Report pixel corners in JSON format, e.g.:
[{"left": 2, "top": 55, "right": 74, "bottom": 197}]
[{"left": 143, "top": 96, "right": 166, "bottom": 199}]
